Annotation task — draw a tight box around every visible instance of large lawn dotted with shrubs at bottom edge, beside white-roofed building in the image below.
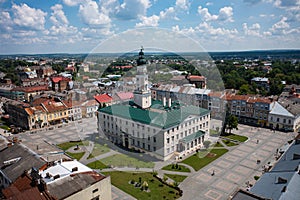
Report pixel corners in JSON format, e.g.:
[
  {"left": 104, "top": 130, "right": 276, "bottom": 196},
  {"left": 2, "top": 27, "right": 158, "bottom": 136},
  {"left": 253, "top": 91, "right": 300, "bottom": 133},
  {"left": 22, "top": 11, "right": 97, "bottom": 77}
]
[{"left": 104, "top": 171, "right": 179, "bottom": 200}]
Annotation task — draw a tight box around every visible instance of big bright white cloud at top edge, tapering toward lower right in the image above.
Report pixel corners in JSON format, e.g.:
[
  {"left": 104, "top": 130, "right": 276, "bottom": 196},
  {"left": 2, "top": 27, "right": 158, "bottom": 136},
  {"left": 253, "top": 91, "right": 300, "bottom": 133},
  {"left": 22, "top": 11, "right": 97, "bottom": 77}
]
[{"left": 79, "top": 0, "right": 111, "bottom": 26}]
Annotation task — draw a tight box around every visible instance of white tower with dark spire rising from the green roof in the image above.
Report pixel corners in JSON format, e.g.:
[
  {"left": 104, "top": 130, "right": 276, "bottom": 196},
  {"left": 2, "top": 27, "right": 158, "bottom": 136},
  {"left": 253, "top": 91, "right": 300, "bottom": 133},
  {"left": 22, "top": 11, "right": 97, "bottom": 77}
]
[{"left": 133, "top": 48, "right": 151, "bottom": 109}]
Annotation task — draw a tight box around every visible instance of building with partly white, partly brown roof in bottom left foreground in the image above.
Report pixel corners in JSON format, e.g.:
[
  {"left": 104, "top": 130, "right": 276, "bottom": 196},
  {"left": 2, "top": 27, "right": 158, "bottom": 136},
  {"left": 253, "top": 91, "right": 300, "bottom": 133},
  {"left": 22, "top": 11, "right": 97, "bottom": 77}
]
[{"left": 40, "top": 160, "right": 112, "bottom": 200}]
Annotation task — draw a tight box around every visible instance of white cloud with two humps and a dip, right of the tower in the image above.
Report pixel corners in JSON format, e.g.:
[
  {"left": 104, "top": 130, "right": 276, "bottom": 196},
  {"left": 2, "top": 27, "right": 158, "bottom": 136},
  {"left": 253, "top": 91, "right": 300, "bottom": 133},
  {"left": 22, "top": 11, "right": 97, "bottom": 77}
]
[{"left": 198, "top": 6, "right": 233, "bottom": 22}]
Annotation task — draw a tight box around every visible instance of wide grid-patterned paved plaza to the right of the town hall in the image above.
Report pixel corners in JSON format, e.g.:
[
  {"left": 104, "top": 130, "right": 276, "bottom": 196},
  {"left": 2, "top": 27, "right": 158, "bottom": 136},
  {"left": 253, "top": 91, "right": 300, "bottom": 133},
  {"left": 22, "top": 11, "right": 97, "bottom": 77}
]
[{"left": 180, "top": 125, "right": 295, "bottom": 200}]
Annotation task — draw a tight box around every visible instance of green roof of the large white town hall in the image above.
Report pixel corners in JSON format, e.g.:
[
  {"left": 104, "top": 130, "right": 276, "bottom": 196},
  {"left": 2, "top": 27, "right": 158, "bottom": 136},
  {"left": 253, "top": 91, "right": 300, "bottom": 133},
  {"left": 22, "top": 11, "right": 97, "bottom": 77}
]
[{"left": 99, "top": 101, "right": 210, "bottom": 129}]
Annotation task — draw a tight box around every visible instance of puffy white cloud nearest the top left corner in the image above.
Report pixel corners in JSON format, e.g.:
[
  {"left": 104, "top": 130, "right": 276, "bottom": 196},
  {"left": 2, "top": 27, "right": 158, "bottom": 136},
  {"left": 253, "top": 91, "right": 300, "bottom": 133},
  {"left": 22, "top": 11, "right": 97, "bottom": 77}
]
[{"left": 12, "top": 4, "right": 47, "bottom": 30}]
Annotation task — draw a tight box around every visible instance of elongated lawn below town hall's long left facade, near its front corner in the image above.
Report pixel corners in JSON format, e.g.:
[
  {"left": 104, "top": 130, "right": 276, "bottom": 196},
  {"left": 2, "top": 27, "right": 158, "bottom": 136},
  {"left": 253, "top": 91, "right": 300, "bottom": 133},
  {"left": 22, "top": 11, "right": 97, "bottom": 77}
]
[{"left": 101, "top": 154, "right": 154, "bottom": 168}]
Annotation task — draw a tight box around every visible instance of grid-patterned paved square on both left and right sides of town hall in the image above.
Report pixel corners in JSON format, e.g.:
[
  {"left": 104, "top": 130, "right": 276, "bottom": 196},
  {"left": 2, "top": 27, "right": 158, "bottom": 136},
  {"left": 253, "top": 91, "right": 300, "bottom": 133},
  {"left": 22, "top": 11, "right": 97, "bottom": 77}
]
[{"left": 5, "top": 118, "right": 295, "bottom": 200}]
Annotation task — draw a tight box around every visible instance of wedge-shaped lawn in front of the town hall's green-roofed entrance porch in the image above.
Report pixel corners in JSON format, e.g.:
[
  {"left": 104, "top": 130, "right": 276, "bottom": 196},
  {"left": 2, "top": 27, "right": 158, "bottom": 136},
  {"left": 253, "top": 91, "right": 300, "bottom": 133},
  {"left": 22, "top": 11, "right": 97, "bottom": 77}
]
[{"left": 182, "top": 149, "right": 228, "bottom": 171}]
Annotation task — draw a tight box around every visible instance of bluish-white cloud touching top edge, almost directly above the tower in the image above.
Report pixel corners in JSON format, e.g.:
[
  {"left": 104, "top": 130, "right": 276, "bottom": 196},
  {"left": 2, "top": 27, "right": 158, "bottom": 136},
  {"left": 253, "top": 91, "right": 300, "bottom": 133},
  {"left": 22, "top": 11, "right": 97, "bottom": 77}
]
[{"left": 116, "top": 0, "right": 151, "bottom": 20}]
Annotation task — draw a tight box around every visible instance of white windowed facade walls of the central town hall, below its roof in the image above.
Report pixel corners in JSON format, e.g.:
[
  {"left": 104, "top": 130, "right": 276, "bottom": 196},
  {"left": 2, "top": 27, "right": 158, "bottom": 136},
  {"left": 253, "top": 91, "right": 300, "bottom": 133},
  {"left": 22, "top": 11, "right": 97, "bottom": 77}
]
[{"left": 98, "top": 109, "right": 210, "bottom": 160}]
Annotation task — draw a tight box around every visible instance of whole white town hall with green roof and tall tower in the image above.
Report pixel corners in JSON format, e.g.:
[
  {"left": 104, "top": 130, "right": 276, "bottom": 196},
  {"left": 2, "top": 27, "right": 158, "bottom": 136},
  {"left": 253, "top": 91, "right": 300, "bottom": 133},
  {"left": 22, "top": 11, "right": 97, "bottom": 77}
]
[{"left": 98, "top": 50, "right": 210, "bottom": 160}]
